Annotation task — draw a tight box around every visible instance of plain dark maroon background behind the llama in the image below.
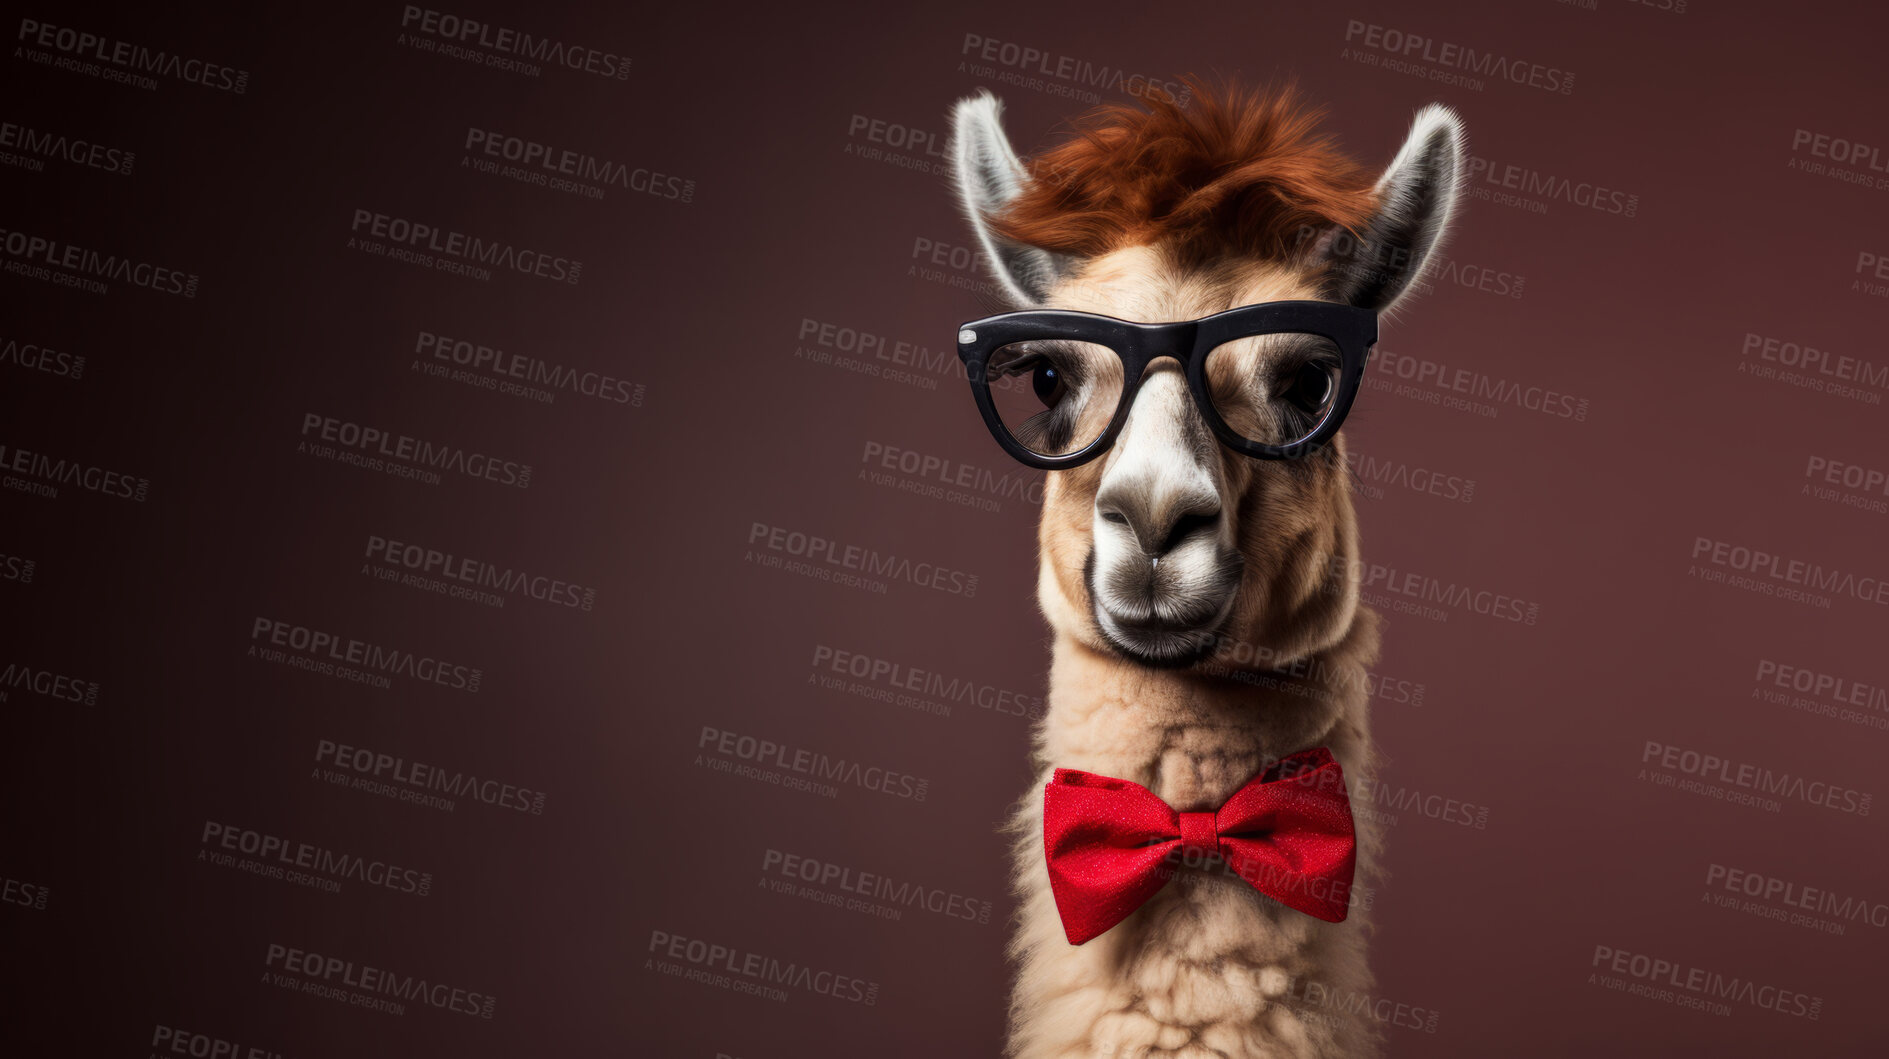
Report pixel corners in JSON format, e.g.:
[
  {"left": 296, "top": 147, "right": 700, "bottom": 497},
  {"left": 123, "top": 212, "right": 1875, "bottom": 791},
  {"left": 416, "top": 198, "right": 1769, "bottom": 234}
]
[{"left": 0, "top": 0, "right": 1889, "bottom": 1059}]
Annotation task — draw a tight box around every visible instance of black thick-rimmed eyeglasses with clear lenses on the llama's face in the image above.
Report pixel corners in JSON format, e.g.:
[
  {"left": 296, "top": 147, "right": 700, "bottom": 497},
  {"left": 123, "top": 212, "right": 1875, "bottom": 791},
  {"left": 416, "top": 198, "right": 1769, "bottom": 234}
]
[{"left": 958, "top": 302, "right": 1377, "bottom": 470}]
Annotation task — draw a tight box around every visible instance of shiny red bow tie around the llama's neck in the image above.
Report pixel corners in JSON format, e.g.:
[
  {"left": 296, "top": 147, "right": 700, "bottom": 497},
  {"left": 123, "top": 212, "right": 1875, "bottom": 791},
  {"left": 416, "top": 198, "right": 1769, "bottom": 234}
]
[{"left": 1043, "top": 748, "right": 1358, "bottom": 946}]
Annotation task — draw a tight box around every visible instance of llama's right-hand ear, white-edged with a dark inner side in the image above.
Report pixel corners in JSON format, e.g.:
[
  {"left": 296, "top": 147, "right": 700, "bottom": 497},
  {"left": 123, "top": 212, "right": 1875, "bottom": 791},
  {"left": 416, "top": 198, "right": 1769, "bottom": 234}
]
[{"left": 1319, "top": 104, "right": 1464, "bottom": 313}]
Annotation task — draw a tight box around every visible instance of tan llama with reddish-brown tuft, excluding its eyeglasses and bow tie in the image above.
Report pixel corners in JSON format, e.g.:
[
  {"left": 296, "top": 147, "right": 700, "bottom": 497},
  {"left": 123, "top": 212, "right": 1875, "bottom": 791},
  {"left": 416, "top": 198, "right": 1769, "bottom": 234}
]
[{"left": 952, "top": 85, "right": 1464, "bottom": 1059}]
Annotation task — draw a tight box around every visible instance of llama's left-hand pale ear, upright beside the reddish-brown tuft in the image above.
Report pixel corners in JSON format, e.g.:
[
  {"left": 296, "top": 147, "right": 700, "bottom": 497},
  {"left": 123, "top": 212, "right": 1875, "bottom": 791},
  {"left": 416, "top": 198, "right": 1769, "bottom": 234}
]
[{"left": 950, "top": 92, "right": 1062, "bottom": 306}]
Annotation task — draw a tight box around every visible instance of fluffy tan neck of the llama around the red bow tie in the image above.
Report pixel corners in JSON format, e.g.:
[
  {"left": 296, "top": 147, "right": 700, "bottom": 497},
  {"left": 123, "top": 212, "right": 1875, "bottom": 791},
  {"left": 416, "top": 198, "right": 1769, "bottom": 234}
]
[{"left": 1011, "top": 581, "right": 1379, "bottom": 1059}]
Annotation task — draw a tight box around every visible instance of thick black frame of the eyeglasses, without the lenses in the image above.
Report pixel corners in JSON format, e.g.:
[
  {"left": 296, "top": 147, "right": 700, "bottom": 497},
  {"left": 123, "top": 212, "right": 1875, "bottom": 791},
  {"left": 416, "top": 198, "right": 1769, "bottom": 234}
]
[{"left": 958, "top": 300, "right": 1377, "bottom": 470}]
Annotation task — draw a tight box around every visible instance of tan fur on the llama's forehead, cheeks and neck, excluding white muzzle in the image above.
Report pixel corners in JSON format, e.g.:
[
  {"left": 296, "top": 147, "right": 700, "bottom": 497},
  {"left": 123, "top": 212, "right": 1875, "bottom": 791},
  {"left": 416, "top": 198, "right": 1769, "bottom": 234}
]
[{"left": 1011, "top": 247, "right": 1379, "bottom": 1059}]
